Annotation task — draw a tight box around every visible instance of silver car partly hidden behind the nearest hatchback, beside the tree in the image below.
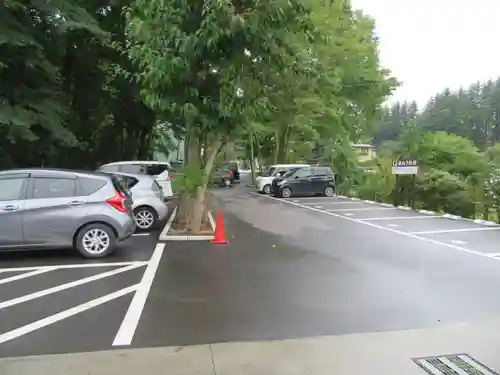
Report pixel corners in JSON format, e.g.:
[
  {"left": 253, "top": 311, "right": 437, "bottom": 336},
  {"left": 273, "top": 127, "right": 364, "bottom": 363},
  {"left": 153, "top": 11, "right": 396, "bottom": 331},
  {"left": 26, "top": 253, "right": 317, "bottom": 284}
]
[{"left": 112, "top": 172, "right": 168, "bottom": 231}]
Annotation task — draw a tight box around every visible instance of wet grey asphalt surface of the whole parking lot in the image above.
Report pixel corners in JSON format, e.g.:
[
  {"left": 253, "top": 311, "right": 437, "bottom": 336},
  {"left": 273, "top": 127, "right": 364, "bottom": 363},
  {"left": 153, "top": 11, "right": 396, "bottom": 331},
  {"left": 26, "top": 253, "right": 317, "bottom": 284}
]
[{"left": 0, "top": 176, "right": 500, "bottom": 356}]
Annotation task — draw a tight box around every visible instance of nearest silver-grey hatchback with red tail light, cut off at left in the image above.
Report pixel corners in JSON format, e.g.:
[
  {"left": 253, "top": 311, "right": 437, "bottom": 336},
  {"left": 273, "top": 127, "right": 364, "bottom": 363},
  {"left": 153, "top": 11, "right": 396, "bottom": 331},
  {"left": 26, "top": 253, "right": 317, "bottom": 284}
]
[{"left": 0, "top": 169, "right": 136, "bottom": 258}]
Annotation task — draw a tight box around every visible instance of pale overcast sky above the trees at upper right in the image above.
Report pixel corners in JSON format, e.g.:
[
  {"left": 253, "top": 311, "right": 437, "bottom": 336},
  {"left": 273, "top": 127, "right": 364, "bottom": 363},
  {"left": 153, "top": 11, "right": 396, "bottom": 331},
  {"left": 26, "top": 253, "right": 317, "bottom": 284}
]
[{"left": 351, "top": 0, "right": 500, "bottom": 105}]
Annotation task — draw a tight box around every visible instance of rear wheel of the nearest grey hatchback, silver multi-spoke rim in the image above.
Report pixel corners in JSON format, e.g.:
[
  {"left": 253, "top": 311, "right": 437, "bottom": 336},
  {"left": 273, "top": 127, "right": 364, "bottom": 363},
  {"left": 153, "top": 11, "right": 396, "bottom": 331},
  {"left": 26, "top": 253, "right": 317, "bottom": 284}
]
[{"left": 75, "top": 223, "right": 116, "bottom": 258}]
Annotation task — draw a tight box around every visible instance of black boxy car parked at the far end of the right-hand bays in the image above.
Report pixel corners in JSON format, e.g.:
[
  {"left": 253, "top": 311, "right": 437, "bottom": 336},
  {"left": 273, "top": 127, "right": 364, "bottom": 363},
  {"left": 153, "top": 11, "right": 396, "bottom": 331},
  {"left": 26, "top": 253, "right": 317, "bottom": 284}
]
[{"left": 272, "top": 167, "right": 335, "bottom": 198}]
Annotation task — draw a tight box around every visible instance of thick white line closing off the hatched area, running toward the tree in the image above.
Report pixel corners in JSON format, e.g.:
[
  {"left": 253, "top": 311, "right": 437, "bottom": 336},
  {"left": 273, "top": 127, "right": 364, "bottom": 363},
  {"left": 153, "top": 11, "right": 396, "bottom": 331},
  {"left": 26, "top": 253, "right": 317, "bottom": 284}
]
[{"left": 113, "top": 243, "right": 165, "bottom": 346}]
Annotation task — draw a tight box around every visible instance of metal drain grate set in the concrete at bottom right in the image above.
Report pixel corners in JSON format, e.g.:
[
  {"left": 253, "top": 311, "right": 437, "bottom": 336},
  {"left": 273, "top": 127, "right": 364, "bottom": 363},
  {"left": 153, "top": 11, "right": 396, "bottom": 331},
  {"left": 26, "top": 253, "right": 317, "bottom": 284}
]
[{"left": 412, "top": 354, "right": 499, "bottom": 375}]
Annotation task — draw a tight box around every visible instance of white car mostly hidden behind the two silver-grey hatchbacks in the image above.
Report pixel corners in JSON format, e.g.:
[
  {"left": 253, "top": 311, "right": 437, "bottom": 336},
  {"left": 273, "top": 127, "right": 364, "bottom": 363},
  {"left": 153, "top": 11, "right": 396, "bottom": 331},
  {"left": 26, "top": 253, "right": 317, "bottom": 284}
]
[{"left": 98, "top": 160, "right": 173, "bottom": 199}]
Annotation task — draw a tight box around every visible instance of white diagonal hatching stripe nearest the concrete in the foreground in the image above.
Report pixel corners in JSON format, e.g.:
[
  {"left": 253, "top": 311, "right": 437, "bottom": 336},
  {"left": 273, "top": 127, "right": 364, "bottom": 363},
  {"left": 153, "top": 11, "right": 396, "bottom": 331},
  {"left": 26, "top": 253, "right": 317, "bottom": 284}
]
[{"left": 0, "top": 284, "right": 139, "bottom": 344}]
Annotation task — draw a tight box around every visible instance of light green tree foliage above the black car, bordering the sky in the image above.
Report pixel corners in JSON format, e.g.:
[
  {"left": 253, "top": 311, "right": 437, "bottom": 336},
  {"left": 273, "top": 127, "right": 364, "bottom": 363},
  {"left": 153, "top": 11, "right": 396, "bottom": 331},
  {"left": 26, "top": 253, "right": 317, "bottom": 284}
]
[{"left": 266, "top": 1, "right": 397, "bottom": 162}]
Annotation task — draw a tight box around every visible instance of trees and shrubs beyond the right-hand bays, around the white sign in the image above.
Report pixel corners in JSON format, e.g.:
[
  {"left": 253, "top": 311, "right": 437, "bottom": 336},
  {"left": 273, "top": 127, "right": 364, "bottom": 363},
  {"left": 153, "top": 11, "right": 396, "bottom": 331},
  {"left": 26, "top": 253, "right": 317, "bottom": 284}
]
[{"left": 356, "top": 79, "right": 500, "bottom": 221}]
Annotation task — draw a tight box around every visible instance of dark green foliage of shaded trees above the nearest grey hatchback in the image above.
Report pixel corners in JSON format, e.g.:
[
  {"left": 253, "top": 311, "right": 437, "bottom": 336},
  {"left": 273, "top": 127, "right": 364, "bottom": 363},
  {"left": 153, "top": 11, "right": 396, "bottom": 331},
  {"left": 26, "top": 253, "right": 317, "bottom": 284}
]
[{"left": 0, "top": 0, "right": 160, "bottom": 168}]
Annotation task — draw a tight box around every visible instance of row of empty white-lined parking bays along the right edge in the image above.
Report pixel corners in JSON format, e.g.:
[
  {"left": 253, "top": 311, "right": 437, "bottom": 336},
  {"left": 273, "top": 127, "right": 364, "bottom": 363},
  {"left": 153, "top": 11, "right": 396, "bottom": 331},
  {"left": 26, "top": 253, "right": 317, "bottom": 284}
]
[{"left": 256, "top": 196, "right": 500, "bottom": 259}]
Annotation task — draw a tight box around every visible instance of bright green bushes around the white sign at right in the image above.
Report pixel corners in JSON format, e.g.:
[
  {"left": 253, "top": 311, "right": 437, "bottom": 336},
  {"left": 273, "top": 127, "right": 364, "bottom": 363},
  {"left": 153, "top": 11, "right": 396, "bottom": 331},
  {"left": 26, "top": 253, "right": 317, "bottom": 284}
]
[{"left": 359, "top": 125, "right": 492, "bottom": 219}]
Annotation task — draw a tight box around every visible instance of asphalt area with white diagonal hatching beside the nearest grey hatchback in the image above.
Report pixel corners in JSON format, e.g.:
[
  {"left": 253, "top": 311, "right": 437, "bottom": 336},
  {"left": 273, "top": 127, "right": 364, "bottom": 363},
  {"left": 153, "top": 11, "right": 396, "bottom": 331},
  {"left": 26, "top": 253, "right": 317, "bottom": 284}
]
[{"left": 0, "top": 225, "right": 164, "bottom": 357}]
